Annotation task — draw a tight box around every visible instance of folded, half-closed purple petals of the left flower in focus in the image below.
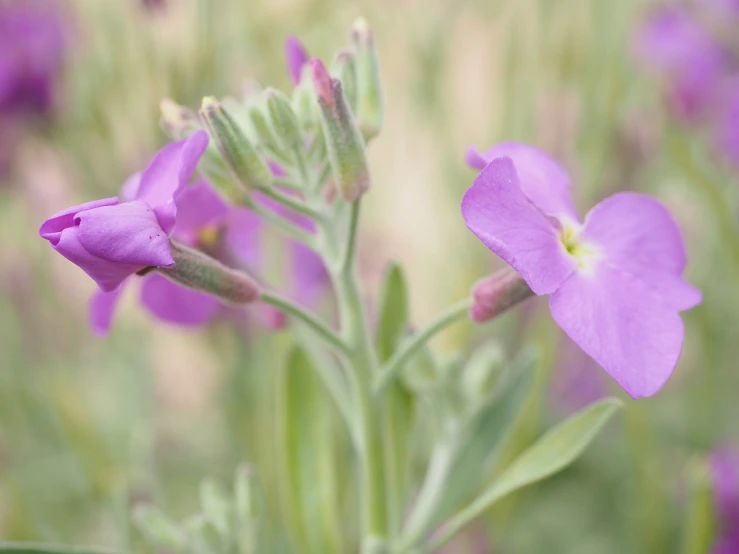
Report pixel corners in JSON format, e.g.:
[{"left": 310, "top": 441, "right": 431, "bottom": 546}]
[{"left": 39, "top": 131, "right": 208, "bottom": 292}]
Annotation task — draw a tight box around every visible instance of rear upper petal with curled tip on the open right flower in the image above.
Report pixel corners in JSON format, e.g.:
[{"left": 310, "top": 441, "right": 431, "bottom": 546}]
[{"left": 474, "top": 142, "right": 579, "bottom": 221}]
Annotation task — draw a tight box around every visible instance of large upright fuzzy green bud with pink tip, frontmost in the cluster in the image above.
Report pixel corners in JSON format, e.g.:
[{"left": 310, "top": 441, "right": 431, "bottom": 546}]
[{"left": 311, "top": 58, "right": 370, "bottom": 202}]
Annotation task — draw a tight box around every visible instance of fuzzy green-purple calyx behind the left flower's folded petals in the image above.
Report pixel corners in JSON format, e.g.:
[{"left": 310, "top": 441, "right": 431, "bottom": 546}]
[{"left": 156, "top": 241, "right": 260, "bottom": 305}]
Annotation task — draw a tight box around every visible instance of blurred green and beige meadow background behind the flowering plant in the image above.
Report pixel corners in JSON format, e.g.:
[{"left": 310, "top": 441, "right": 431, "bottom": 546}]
[{"left": 0, "top": 0, "right": 739, "bottom": 554}]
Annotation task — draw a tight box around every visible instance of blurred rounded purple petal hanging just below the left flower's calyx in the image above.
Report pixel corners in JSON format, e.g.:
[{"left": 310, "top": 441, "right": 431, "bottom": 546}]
[{"left": 141, "top": 273, "right": 223, "bottom": 327}]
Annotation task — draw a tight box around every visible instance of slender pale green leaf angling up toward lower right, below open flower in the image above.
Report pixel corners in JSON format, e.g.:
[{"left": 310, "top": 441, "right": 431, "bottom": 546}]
[{"left": 423, "top": 398, "right": 623, "bottom": 552}]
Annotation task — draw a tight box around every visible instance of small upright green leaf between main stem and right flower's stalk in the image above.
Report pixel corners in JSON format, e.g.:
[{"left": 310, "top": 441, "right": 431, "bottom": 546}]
[{"left": 377, "top": 262, "right": 408, "bottom": 363}]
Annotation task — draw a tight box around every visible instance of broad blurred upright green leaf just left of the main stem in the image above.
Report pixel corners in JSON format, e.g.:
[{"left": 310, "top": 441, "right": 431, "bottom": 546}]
[{"left": 277, "top": 347, "right": 342, "bottom": 554}]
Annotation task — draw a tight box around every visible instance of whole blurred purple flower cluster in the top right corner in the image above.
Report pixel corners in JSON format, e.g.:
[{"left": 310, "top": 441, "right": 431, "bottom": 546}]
[{"left": 636, "top": 0, "right": 739, "bottom": 167}]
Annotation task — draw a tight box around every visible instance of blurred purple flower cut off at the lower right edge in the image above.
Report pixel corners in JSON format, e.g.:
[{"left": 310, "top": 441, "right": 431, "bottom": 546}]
[{"left": 710, "top": 446, "right": 739, "bottom": 554}]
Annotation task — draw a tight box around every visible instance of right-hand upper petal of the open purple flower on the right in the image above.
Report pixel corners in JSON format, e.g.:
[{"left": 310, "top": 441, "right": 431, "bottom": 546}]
[{"left": 582, "top": 192, "right": 702, "bottom": 310}]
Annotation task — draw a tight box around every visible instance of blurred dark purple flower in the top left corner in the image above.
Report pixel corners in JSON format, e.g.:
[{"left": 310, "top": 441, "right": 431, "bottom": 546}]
[{"left": 0, "top": 0, "right": 65, "bottom": 113}]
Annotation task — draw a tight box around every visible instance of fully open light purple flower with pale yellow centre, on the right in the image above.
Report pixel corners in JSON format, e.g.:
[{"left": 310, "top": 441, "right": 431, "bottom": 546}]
[{"left": 462, "top": 143, "right": 701, "bottom": 398}]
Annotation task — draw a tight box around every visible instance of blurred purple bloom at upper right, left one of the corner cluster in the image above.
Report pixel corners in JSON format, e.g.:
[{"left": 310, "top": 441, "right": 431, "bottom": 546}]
[{"left": 636, "top": 6, "right": 727, "bottom": 118}]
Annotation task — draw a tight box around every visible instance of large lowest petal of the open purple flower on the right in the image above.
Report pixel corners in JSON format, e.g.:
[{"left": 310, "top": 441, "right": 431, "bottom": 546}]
[{"left": 549, "top": 264, "right": 683, "bottom": 398}]
